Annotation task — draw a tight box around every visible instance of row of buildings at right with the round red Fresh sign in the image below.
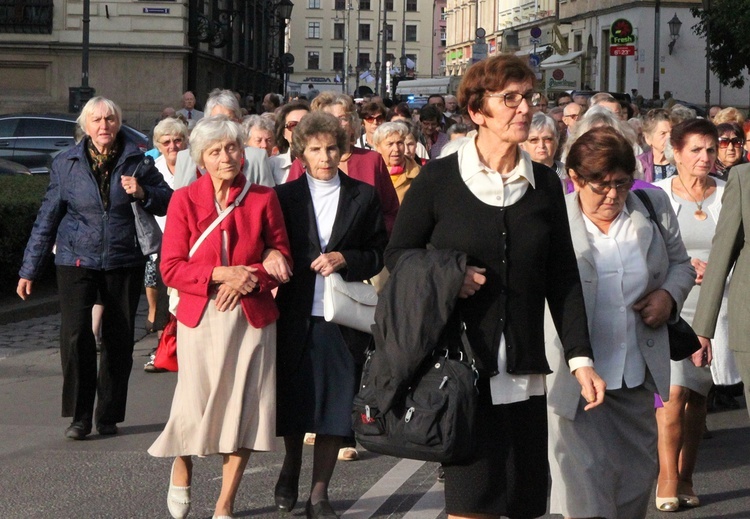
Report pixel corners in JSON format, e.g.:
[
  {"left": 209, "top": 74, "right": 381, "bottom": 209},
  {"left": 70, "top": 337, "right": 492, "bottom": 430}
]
[{"left": 442, "top": 0, "right": 750, "bottom": 107}]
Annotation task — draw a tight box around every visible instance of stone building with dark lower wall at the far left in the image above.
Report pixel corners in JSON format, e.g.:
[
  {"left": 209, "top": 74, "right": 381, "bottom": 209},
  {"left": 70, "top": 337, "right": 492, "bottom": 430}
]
[{"left": 0, "top": 0, "right": 284, "bottom": 130}]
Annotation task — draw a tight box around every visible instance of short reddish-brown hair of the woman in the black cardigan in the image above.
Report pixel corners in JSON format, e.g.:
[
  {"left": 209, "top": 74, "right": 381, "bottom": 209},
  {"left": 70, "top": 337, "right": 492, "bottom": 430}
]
[{"left": 458, "top": 54, "right": 536, "bottom": 112}]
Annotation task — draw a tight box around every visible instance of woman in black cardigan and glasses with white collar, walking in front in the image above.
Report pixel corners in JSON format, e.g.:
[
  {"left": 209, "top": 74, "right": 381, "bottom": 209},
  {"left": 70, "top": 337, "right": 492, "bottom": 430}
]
[{"left": 386, "top": 56, "right": 604, "bottom": 518}]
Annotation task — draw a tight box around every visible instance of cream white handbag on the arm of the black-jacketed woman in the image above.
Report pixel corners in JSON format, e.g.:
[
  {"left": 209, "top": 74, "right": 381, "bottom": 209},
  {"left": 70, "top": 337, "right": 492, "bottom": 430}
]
[{"left": 323, "top": 272, "right": 378, "bottom": 333}]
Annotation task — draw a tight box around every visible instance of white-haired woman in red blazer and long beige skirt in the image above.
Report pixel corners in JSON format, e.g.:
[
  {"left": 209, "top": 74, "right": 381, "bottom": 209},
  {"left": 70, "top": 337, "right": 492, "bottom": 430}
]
[{"left": 149, "top": 116, "right": 292, "bottom": 518}]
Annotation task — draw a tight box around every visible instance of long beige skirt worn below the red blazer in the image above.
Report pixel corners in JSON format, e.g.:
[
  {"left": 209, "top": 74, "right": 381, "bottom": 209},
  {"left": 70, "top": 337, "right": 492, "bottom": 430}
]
[{"left": 148, "top": 301, "right": 277, "bottom": 457}]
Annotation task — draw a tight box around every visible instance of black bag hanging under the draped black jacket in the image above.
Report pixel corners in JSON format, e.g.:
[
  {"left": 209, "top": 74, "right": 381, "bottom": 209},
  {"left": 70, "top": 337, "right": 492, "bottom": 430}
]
[{"left": 352, "top": 333, "right": 477, "bottom": 463}]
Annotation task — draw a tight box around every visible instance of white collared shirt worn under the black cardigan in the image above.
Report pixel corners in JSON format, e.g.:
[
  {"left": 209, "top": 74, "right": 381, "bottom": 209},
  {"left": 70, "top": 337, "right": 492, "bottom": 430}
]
[{"left": 458, "top": 139, "right": 545, "bottom": 405}]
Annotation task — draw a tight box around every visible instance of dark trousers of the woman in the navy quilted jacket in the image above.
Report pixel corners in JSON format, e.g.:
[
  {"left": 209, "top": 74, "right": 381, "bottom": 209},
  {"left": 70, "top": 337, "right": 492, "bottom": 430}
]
[{"left": 57, "top": 266, "right": 144, "bottom": 424}]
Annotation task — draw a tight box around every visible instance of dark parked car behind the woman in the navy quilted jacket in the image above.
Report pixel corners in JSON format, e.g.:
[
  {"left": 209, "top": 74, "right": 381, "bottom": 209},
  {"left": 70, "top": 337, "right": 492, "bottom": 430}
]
[{"left": 0, "top": 113, "right": 151, "bottom": 174}]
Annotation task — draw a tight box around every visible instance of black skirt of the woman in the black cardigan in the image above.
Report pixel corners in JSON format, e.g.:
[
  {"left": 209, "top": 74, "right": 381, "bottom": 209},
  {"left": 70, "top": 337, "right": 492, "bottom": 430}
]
[{"left": 444, "top": 379, "right": 549, "bottom": 519}]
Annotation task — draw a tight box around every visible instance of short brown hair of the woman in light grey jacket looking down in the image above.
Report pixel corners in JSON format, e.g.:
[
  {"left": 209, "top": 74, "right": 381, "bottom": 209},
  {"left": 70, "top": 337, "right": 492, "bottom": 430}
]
[{"left": 565, "top": 126, "right": 635, "bottom": 185}]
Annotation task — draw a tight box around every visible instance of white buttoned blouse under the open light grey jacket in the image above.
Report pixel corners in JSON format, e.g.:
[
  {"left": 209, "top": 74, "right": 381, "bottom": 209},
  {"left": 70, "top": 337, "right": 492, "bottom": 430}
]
[{"left": 583, "top": 208, "right": 648, "bottom": 389}]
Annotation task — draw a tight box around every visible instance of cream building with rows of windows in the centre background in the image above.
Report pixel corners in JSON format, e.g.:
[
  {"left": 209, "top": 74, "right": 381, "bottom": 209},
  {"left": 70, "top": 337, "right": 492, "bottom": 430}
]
[{"left": 287, "top": 0, "right": 445, "bottom": 96}]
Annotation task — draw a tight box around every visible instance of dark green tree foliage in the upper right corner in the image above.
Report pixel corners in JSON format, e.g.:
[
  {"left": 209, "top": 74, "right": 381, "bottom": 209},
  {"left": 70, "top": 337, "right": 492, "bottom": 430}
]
[{"left": 690, "top": 0, "right": 750, "bottom": 88}]
